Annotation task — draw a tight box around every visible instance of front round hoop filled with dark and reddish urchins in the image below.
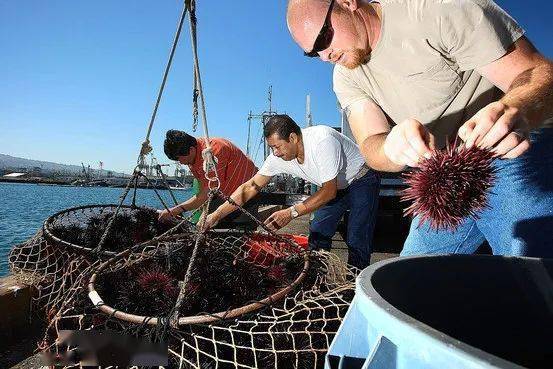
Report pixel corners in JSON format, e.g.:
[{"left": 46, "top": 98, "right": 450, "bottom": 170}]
[{"left": 88, "top": 231, "right": 310, "bottom": 325}]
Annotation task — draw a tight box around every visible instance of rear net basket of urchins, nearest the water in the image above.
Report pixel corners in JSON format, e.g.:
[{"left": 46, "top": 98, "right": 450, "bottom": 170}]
[{"left": 9, "top": 205, "right": 187, "bottom": 319}]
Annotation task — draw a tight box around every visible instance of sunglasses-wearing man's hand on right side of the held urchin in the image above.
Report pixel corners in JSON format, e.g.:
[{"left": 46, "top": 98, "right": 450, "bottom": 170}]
[{"left": 458, "top": 101, "right": 530, "bottom": 159}]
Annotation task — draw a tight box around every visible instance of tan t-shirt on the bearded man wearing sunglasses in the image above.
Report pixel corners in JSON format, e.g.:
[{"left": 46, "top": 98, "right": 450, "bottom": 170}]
[{"left": 334, "top": 0, "right": 524, "bottom": 147}]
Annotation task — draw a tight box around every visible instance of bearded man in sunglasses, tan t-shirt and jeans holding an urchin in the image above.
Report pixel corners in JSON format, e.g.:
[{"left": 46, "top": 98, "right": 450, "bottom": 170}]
[{"left": 287, "top": 0, "right": 553, "bottom": 257}]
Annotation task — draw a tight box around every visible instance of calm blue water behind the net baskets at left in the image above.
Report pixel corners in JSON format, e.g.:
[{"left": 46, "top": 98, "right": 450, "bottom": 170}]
[{"left": 0, "top": 182, "right": 191, "bottom": 276}]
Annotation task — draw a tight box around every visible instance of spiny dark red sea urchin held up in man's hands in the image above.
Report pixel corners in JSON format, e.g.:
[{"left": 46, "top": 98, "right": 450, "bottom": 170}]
[{"left": 401, "top": 144, "right": 496, "bottom": 231}]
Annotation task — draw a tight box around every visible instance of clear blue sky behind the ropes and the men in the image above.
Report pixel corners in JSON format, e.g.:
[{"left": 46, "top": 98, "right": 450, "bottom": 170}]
[{"left": 0, "top": 0, "right": 553, "bottom": 172}]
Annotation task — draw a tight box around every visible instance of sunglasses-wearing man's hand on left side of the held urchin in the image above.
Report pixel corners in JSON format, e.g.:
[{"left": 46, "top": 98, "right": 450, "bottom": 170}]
[{"left": 384, "top": 119, "right": 434, "bottom": 167}]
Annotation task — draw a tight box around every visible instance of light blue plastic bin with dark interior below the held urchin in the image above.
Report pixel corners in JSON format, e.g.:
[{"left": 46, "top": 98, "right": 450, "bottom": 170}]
[{"left": 325, "top": 255, "right": 553, "bottom": 369}]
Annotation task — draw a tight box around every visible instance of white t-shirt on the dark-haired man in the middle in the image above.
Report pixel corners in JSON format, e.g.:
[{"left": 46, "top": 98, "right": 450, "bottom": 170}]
[{"left": 258, "top": 126, "right": 365, "bottom": 190}]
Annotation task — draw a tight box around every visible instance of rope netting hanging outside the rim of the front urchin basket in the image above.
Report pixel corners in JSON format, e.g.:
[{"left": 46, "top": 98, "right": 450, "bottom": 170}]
[{"left": 42, "top": 244, "right": 358, "bottom": 369}]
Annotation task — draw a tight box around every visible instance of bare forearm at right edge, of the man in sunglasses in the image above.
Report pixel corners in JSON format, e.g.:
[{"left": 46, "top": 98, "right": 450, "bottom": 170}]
[{"left": 501, "top": 61, "right": 553, "bottom": 128}]
